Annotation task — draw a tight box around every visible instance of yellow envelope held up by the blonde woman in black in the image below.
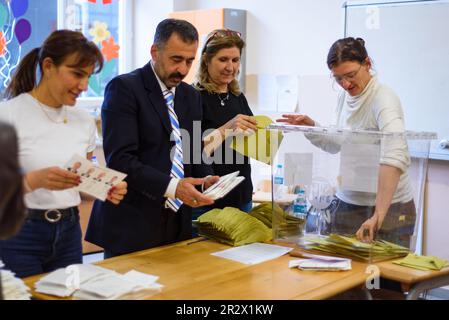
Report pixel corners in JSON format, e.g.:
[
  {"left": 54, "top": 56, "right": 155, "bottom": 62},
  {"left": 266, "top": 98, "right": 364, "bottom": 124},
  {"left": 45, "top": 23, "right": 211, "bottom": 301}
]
[{"left": 230, "top": 116, "right": 283, "bottom": 164}]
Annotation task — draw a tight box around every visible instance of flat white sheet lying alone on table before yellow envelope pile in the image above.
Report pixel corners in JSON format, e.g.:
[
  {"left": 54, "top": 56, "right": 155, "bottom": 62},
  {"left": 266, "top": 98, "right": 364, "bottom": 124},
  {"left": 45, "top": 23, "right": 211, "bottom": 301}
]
[{"left": 212, "top": 242, "right": 293, "bottom": 265}]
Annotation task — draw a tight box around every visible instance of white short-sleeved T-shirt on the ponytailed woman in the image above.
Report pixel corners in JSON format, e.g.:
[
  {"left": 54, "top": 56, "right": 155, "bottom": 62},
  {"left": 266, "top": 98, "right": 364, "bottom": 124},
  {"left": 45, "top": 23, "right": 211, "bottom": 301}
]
[{"left": 0, "top": 93, "right": 96, "bottom": 209}]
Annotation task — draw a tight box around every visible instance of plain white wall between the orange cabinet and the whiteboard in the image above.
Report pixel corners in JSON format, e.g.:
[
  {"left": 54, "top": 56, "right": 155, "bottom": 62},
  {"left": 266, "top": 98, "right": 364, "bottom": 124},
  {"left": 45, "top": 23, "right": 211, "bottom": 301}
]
[{"left": 174, "top": 0, "right": 344, "bottom": 74}]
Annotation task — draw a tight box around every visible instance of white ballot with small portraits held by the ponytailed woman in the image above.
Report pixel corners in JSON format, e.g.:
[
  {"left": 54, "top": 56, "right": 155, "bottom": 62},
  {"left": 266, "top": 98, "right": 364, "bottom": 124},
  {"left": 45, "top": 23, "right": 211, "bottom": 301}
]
[{"left": 64, "top": 154, "right": 126, "bottom": 201}]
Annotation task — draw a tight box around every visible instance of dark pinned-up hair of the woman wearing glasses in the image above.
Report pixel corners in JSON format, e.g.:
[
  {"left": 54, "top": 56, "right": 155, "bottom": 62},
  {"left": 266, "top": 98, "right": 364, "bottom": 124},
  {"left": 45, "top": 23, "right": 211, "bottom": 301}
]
[{"left": 327, "top": 37, "right": 368, "bottom": 69}]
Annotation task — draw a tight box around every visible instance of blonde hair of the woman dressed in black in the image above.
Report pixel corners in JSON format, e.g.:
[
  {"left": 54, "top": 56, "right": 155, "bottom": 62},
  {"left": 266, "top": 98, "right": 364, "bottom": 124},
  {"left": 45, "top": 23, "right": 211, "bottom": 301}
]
[{"left": 195, "top": 29, "right": 245, "bottom": 96}]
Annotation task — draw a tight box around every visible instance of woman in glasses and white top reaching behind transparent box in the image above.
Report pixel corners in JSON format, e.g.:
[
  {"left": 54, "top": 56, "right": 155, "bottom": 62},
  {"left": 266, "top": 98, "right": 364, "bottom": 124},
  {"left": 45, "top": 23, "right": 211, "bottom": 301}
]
[{"left": 278, "top": 38, "right": 416, "bottom": 247}]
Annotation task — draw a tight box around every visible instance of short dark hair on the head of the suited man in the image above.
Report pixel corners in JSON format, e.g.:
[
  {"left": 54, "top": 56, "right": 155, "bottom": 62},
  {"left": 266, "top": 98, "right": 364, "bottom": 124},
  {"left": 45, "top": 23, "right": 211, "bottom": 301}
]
[{"left": 154, "top": 19, "right": 198, "bottom": 49}]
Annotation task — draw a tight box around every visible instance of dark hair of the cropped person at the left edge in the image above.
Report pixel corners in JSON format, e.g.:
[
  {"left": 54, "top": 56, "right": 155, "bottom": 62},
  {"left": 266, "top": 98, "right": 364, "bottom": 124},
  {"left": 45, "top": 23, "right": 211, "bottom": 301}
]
[{"left": 0, "top": 121, "right": 26, "bottom": 239}]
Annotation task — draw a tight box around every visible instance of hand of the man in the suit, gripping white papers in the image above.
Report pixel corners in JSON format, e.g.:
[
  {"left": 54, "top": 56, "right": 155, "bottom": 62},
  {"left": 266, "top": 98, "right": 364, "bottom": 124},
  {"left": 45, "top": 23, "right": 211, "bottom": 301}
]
[{"left": 175, "top": 178, "right": 214, "bottom": 208}]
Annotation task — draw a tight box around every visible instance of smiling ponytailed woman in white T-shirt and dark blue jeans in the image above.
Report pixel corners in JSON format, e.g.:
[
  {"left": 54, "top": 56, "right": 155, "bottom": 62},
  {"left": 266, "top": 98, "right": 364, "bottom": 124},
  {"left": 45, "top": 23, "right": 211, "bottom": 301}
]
[{"left": 0, "top": 30, "right": 126, "bottom": 277}]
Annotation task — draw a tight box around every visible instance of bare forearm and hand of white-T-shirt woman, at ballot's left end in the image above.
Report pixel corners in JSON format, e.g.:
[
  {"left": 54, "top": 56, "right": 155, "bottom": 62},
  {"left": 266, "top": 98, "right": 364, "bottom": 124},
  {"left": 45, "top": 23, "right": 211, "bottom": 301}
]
[{"left": 25, "top": 167, "right": 81, "bottom": 190}]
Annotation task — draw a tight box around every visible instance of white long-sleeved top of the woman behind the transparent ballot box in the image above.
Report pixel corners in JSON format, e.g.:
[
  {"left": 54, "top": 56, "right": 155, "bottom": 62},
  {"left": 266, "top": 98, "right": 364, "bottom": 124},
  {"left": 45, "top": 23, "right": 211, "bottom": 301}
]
[{"left": 306, "top": 76, "right": 413, "bottom": 206}]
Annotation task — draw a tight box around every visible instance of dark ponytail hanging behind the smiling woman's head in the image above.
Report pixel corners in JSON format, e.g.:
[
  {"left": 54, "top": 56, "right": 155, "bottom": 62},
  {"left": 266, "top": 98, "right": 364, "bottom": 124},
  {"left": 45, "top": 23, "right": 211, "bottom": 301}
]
[{"left": 4, "top": 48, "right": 40, "bottom": 99}]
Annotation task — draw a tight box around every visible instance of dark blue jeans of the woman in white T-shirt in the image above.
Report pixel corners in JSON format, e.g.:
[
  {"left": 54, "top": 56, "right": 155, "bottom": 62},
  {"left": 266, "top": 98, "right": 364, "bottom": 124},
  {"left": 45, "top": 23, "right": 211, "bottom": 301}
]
[{"left": 0, "top": 214, "right": 82, "bottom": 278}]
